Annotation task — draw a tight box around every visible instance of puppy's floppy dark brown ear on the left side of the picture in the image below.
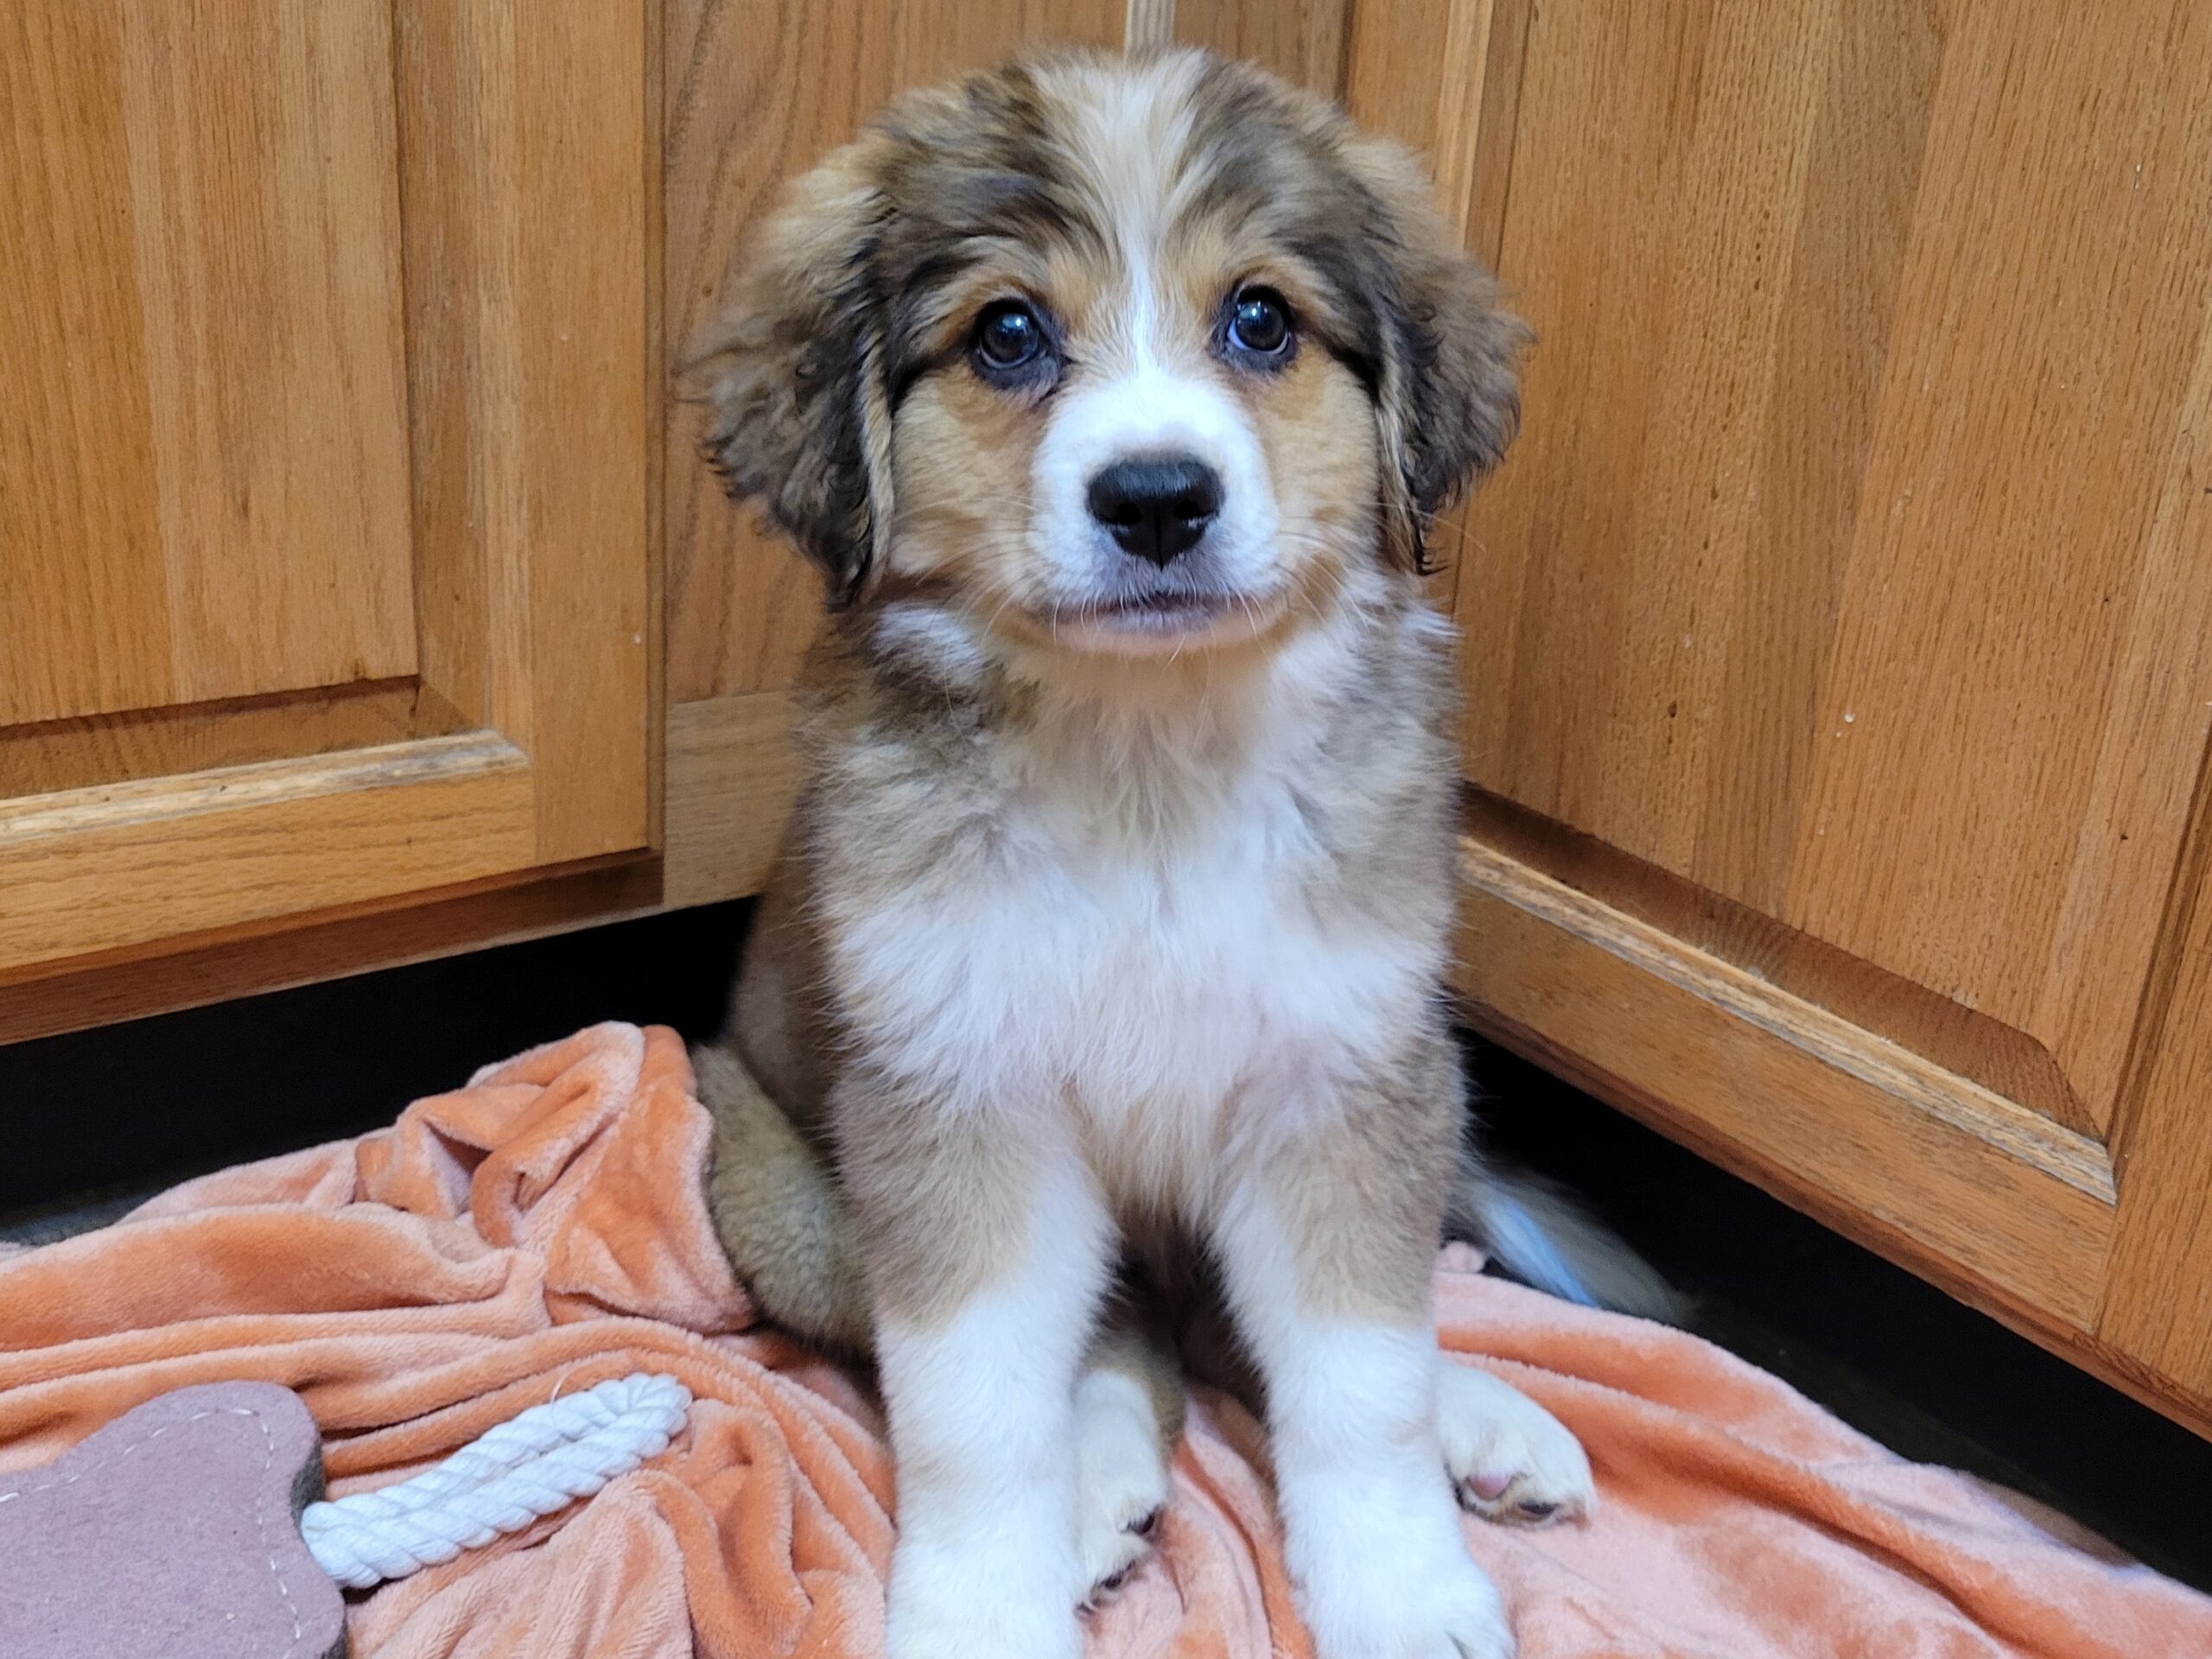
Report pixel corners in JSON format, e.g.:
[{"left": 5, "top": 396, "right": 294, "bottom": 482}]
[{"left": 679, "top": 139, "right": 892, "bottom": 606}]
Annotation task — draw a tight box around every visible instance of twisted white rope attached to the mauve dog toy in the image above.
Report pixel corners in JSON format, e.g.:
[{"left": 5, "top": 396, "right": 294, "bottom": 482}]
[{"left": 299, "top": 1371, "right": 690, "bottom": 1591}]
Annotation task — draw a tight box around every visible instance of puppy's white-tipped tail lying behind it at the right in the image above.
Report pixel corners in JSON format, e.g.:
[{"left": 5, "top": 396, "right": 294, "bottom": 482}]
[{"left": 1445, "top": 1154, "right": 1690, "bottom": 1325}]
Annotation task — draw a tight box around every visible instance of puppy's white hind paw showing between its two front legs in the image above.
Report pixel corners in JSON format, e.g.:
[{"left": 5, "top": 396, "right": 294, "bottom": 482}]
[{"left": 1075, "top": 1300, "right": 1184, "bottom": 1606}]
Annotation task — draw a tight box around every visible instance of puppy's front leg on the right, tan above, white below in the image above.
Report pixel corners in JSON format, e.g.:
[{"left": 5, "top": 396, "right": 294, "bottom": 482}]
[{"left": 1214, "top": 1055, "right": 1513, "bottom": 1659}]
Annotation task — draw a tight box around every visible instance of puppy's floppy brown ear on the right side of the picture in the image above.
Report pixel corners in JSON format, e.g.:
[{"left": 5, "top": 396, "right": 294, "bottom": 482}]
[{"left": 1347, "top": 139, "right": 1535, "bottom": 570}]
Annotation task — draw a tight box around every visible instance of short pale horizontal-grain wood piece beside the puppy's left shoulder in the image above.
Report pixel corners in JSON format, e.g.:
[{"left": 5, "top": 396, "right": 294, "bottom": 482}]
[{"left": 661, "top": 692, "right": 798, "bottom": 907}]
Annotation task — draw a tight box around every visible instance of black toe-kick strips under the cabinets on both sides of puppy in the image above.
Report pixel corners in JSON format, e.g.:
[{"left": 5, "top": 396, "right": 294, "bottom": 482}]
[{"left": 13, "top": 905, "right": 2212, "bottom": 1591}]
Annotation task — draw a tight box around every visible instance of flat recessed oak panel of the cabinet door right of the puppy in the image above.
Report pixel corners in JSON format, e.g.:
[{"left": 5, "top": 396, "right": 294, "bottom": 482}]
[{"left": 1451, "top": 0, "right": 2212, "bottom": 1137}]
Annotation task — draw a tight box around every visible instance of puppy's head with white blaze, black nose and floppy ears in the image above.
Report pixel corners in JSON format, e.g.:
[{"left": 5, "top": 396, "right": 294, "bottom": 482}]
[{"left": 688, "top": 53, "right": 1524, "bottom": 655}]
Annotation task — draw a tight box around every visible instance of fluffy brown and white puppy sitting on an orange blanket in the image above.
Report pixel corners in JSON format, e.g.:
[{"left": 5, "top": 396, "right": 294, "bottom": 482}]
[{"left": 688, "top": 53, "right": 1663, "bottom": 1659}]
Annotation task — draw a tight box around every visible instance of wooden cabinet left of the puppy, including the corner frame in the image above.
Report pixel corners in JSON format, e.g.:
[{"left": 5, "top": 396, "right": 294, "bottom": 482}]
[{"left": 0, "top": 0, "right": 1141, "bottom": 1042}]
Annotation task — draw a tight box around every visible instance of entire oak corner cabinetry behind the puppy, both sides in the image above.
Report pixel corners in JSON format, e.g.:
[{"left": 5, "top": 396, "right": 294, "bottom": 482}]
[{"left": 0, "top": 0, "right": 2212, "bottom": 1427}]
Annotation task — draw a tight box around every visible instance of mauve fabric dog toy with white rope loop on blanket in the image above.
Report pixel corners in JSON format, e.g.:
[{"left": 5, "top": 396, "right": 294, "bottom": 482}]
[{"left": 0, "top": 1374, "right": 690, "bottom": 1659}]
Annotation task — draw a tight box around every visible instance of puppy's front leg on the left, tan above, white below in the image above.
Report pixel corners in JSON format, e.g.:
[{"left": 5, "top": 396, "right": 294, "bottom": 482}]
[{"left": 836, "top": 1090, "right": 1113, "bottom": 1659}]
